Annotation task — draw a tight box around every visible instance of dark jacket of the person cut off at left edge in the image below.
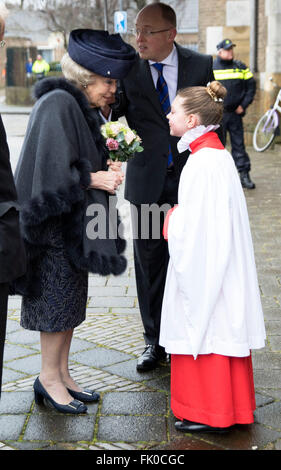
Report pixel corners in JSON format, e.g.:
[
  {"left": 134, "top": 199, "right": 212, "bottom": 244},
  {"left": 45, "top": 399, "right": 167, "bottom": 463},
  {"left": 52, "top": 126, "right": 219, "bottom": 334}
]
[{"left": 0, "top": 116, "right": 26, "bottom": 283}]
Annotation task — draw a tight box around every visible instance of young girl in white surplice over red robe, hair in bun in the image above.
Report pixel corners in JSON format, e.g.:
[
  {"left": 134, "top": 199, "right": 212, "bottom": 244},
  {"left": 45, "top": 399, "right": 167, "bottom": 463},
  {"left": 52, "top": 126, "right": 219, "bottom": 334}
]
[{"left": 160, "top": 82, "right": 265, "bottom": 432}]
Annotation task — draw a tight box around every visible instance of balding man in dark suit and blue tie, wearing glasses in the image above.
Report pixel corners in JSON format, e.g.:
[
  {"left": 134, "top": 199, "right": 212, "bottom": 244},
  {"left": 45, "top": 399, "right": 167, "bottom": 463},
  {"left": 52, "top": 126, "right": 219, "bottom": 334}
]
[{"left": 109, "top": 3, "right": 214, "bottom": 371}]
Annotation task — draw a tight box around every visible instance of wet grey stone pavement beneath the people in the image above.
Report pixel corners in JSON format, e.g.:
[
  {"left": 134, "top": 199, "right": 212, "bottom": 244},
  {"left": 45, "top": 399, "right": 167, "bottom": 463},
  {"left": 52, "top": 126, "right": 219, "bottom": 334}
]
[{"left": 0, "top": 111, "right": 281, "bottom": 451}]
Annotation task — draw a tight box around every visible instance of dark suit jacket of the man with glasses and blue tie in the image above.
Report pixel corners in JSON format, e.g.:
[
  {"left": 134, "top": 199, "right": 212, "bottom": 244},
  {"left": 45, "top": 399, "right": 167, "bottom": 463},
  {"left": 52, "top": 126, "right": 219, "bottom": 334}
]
[{"left": 113, "top": 44, "right": 214, "bottom": 204}]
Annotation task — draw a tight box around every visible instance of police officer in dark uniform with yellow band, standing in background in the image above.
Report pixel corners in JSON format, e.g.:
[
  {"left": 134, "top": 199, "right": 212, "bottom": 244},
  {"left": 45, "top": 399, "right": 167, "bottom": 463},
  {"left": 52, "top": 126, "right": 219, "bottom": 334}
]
[{"left": 214, "top": 39, "right": 256, "bottom": 189}]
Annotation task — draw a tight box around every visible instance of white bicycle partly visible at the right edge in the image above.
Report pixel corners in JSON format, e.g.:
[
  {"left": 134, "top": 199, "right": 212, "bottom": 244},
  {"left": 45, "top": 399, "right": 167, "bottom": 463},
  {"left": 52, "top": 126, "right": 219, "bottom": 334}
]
[{"left": 253, "top": 77, "right": 281, "bottom": 152}]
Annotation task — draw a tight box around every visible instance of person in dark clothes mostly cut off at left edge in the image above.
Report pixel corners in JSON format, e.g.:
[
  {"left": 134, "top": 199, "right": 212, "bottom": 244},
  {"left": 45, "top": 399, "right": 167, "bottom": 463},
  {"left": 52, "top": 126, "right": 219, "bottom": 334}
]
[{"left": 0, "top": 11, "right": 26, "bottom": 395}]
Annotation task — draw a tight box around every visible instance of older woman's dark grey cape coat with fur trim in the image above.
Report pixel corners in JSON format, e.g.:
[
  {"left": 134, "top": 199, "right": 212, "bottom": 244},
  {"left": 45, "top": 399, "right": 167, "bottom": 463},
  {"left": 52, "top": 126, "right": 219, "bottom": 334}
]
[{"left": 15, "top": 78, "right": 126, "bottom": 295}]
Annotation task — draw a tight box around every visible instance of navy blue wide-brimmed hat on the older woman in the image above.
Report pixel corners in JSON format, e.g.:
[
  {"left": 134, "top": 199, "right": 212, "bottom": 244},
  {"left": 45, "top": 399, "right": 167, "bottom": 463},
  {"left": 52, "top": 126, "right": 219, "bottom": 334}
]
[{"left": 68, "top": 29, "right": 136, "bottom": 79}]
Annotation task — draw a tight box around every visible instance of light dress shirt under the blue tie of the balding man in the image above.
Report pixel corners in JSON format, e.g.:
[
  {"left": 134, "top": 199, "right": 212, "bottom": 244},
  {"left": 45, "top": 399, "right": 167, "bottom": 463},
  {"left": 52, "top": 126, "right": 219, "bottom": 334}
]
[{"left": 148, "top": 45, "right": 178, "bottom": 104}]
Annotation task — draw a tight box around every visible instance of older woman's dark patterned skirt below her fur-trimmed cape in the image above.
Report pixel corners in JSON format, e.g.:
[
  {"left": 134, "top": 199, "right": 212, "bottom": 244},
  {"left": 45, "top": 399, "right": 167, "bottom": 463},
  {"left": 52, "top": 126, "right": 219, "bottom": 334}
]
[{"left": 21, "top": 218, "right": 88, "bottom": 332}]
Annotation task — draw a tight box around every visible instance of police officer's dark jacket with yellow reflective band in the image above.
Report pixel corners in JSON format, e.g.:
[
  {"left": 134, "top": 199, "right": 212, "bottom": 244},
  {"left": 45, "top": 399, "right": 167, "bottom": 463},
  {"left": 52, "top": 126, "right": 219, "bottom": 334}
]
[{"left": 214, "top": 57, "right": 256, "bottom": 112}]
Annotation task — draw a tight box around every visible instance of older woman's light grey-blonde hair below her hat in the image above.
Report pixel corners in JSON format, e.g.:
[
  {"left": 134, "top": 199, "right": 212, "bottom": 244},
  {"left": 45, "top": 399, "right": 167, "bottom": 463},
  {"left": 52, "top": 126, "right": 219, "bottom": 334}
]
[{"left": 60, "top": 52, "right": 96, "bottom": 90}]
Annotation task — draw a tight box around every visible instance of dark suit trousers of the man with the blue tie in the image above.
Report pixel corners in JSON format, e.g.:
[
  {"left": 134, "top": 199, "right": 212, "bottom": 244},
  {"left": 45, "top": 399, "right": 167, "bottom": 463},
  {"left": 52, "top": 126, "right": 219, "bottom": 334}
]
[{"left": 131, "top": 172, "right": 178, "bottom": 344}]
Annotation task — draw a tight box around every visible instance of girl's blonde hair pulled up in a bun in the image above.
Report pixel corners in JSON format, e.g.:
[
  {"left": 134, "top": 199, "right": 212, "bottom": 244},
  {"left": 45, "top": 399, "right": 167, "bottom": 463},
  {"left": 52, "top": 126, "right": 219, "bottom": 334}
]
[{"left": 178, "top": 81, "right": 227, "bottom": 126}]
